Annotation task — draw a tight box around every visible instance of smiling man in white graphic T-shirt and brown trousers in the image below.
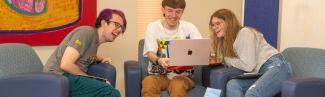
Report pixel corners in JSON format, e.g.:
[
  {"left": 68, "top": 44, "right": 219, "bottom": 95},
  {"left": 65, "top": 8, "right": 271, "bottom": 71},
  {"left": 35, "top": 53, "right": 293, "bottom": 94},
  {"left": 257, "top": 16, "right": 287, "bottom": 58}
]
[{"left": 141, "top": 0, "right": 202, "bottom": 97}]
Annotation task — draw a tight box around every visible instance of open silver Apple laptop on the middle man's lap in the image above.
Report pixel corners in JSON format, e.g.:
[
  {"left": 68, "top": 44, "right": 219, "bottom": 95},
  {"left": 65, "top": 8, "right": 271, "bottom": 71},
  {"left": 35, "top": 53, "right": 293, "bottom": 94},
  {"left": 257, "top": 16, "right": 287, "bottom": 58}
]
[{"left": 167, "top": 39, "right": 211, "bottom": 66}]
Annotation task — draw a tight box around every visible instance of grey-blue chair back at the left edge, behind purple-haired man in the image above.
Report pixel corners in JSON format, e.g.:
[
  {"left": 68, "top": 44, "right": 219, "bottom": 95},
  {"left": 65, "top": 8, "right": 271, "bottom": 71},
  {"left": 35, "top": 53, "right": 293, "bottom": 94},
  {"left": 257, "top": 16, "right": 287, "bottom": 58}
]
[{"left": 0, "top": 43, "right": 43, "bottom": 78}]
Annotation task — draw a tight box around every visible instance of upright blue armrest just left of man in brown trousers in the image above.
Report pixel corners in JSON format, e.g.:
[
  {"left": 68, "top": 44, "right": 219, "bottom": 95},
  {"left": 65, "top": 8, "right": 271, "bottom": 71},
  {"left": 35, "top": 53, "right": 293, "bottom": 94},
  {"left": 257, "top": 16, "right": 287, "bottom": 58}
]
[{"left": 124, "top": 61, "right": 141, "bottom": 97}]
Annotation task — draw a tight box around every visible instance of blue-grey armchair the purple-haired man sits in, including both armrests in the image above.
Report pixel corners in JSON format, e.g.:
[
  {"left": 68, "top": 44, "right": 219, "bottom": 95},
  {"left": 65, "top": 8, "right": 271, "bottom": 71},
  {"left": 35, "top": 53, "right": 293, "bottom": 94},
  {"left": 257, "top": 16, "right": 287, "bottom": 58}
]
[{"left": 0, "top": 43, "right": 115, "bottom": 97}]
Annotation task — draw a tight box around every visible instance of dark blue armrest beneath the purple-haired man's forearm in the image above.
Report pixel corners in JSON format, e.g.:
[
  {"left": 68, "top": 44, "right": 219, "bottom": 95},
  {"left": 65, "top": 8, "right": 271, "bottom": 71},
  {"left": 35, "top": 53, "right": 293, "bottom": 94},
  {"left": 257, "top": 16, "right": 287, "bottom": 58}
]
[{"left": 87, "top": 63, "right": 116, "bottom": 87}]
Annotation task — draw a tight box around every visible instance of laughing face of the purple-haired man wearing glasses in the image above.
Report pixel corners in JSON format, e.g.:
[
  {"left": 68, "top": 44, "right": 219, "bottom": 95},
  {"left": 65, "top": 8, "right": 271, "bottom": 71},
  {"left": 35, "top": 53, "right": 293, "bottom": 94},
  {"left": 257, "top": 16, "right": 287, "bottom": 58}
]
[{"left": 101, "top": 13, "right": 124, "bottom": 42}]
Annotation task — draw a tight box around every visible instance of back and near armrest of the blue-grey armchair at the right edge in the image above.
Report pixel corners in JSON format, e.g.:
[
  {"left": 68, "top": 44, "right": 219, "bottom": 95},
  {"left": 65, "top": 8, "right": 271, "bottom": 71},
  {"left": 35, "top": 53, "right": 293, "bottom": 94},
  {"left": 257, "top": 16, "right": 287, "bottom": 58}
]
[{"left": 281, "top": 47, "right": 325, "bottom": 97}]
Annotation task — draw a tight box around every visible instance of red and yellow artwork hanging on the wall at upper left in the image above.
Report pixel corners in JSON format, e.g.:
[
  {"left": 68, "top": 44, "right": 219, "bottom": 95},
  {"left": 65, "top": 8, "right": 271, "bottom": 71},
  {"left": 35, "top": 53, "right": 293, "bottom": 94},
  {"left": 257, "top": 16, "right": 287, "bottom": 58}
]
[{"left": 0, "top": 0, "right": 96, "bottom": 46}]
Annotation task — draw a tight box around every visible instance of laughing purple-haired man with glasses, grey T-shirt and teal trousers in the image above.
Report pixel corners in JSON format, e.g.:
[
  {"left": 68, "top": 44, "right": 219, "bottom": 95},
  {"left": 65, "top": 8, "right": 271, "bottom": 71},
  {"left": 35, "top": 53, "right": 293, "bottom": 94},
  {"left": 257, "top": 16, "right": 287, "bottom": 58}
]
[{"left": 44, "top": 9, "right": 126, "bottom": 97}]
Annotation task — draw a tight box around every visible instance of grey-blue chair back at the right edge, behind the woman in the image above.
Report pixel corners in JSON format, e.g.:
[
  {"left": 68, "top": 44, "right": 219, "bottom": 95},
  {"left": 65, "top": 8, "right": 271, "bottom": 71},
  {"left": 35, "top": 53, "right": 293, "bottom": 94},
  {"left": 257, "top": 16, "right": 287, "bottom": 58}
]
[{"left": 282, "top": 47, "right": 325, "bottom": 78}]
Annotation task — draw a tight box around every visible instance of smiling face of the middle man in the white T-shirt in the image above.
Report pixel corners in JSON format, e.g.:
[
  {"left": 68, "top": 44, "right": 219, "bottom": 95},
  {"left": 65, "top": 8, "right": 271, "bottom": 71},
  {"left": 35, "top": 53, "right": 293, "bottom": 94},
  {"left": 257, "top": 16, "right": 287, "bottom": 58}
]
[{"left": 162, "top": 6, "right": 184, "bottom": 27}]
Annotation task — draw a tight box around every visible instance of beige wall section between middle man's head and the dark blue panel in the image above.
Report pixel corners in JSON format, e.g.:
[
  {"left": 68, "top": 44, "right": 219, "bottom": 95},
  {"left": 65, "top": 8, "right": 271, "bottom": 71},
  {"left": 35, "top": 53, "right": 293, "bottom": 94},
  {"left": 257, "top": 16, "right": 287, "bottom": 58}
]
[{"left": 182, "top": 0, "right": 243, "bottom": 38}]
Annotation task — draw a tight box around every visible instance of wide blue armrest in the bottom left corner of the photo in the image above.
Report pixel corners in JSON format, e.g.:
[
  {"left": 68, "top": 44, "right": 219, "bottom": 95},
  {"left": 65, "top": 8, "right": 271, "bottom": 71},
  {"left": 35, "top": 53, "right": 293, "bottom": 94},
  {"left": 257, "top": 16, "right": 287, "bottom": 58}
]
[{"left": 0, "top": 73, "right": 69, "bottom": 97}]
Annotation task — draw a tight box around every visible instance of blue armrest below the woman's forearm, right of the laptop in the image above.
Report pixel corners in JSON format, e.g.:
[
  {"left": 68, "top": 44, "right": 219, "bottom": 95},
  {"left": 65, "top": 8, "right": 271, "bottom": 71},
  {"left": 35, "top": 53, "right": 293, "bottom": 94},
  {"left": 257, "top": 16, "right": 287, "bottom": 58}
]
[{"left": 203, "top": 65, "right": 244, "bottom": 97}]
